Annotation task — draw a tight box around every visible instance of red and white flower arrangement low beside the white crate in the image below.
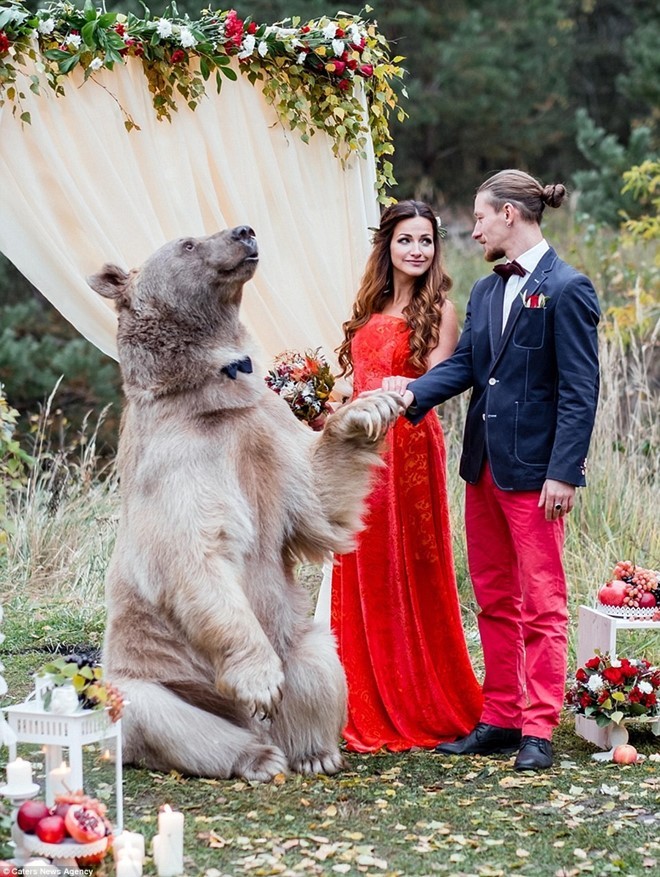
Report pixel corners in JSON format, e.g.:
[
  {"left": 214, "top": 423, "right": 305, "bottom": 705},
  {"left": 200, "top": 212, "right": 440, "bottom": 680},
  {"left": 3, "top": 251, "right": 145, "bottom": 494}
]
[{"left": 566, "top": 651, "right": 660, "bottom": 727}]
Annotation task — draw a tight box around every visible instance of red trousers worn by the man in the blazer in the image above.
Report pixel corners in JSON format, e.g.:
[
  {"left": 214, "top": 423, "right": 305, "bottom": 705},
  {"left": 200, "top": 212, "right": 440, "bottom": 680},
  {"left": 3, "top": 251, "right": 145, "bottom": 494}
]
[{"left": 465, "top": 464, "right": 568, "bottom": 740}]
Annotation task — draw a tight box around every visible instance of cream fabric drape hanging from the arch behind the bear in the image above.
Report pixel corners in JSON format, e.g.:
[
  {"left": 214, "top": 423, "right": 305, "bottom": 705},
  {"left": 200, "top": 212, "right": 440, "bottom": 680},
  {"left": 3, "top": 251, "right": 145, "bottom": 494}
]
[{"left": 0, "top": 59, "right": 379, "bottom": 366}]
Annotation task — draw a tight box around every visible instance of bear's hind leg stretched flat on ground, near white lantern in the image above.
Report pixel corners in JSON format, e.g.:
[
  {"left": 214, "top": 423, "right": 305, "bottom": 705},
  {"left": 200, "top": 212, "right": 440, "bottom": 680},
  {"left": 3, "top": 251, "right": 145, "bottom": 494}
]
[{"left": 116, "top": 679, "right": 287, "bottom": 782}]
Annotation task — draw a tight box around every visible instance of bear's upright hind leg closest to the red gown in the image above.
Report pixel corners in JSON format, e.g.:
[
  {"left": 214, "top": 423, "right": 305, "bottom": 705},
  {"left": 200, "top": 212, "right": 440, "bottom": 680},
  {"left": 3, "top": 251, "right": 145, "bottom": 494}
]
[{"left": 271, "top": 624, "right": 346, "bottom": 774}]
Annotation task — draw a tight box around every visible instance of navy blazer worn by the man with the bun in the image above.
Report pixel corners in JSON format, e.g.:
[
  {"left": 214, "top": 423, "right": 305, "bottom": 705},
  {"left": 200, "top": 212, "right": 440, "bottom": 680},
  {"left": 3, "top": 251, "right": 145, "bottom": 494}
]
[{"left": 406, "top": 248, "right": 600, "bottom": 490}]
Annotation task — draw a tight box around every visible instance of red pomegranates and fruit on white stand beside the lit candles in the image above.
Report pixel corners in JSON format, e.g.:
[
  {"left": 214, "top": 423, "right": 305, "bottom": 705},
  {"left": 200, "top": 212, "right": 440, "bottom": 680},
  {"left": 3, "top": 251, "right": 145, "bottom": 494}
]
[{"left": 16, "top": 792, "right": 112, "bottom": 867}]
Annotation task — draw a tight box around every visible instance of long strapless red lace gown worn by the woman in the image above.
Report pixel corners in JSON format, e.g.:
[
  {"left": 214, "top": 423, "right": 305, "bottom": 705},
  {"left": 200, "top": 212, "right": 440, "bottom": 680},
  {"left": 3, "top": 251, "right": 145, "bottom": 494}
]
[{"left": 332, "top": 314, "right": 481, "bottom": 752}]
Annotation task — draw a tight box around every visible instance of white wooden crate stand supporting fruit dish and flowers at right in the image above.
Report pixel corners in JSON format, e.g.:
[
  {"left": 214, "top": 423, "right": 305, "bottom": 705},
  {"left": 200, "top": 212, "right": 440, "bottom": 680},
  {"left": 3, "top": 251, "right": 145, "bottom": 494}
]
[{"left": 575, "top": 606, "right": 660, "bottom": 749}]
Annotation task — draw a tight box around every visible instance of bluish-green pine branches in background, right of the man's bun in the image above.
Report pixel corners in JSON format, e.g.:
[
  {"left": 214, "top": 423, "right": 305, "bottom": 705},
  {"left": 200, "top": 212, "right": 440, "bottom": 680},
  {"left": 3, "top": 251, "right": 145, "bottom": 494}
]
[{"left": 573, "top": 110, "right": 652, "bottom": 226}]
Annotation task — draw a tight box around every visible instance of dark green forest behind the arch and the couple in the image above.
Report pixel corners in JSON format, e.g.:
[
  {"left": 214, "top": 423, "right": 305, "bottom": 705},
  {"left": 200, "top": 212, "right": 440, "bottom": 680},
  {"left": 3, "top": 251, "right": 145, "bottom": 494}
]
[{"left": 0, "top": 0, "right": 660, "bottom": 444}]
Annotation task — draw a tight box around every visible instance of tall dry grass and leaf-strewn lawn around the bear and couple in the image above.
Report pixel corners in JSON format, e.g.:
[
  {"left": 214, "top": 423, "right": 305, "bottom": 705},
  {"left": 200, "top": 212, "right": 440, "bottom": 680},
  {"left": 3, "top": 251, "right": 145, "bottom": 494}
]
[{"left": 0, "top": 214, "right": 660, "bottom": 877}]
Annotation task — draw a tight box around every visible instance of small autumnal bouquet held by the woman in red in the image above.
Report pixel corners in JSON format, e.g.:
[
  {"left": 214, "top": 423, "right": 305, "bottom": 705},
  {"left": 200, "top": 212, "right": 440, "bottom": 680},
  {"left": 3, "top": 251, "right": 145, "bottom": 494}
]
[{"left": 264, "top": 348, "right": 335, "bottom": 429}]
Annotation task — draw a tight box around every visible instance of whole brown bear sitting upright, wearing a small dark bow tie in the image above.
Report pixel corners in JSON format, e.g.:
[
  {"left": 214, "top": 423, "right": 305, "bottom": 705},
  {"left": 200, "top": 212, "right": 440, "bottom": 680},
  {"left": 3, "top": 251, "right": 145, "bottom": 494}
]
[{"left": 88, "top": 226, "right": 402, "bottom": 780}]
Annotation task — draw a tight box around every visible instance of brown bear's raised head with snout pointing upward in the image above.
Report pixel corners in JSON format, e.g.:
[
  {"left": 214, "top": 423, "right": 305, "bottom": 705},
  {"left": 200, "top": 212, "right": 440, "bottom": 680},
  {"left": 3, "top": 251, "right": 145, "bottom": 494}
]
[{"left": 87, "top": 225, "right": 259, "bottom": 395}]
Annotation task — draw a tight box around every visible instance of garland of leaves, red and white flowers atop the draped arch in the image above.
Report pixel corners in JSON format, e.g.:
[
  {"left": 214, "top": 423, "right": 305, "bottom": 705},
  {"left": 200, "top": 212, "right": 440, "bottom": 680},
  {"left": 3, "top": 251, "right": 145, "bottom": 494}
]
[{"left": 0, "top": 0, "right": 406, "bottom": 203}]
